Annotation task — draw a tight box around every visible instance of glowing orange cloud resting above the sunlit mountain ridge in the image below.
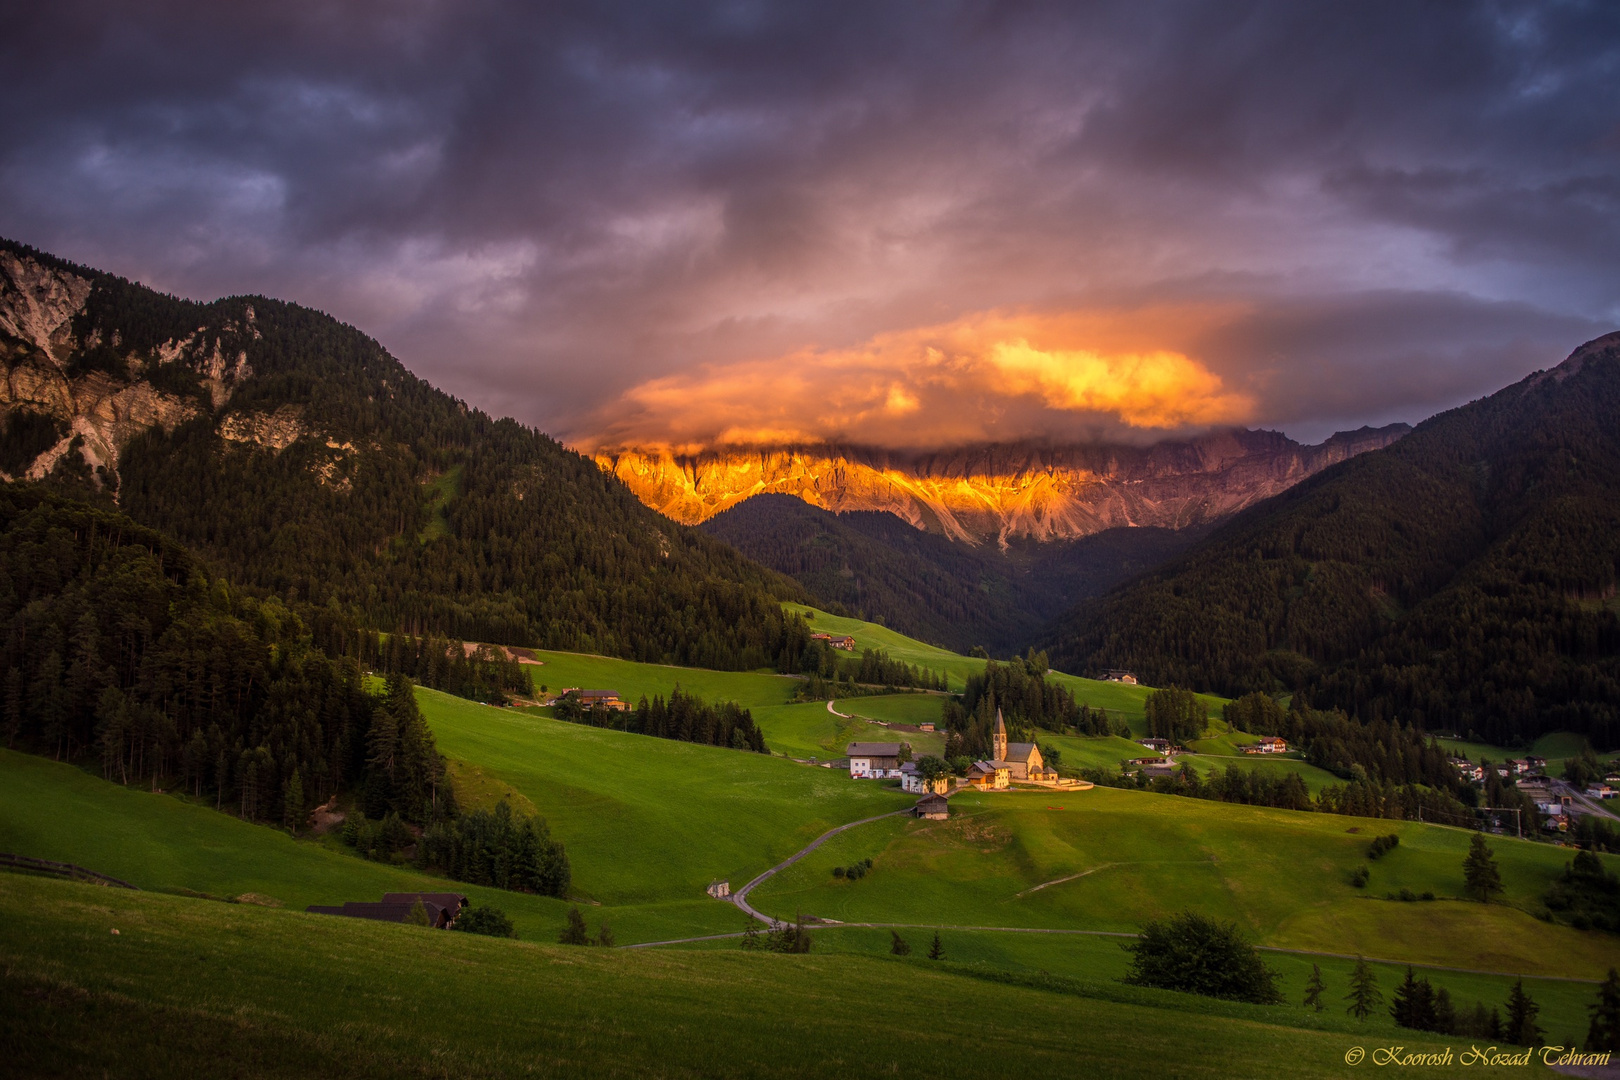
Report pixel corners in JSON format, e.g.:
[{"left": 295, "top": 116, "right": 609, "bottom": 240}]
[{"left": 575, "top": 313, "right": 1256, "bottom": 452}]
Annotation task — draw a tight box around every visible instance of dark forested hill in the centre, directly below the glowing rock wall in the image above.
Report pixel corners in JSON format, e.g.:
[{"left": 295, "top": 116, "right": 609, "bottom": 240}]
[{"left": 698, "top": 494, "right": 1205, "bottom": 656}]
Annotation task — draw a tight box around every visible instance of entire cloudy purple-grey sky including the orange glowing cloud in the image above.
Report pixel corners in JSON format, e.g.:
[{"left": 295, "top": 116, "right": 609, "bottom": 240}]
[{"left": 0, "top": 0, "right": 1620, "bottom": 449}]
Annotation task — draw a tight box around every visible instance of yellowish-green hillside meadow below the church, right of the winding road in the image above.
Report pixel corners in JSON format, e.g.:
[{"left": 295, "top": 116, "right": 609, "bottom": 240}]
[{"left": 750, "top": 789, "right": 1620, "bottom": 978}]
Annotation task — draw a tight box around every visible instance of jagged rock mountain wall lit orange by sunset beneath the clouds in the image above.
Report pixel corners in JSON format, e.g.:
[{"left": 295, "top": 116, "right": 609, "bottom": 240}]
[{"left": 595, "top": 424, "right": 1409, "bottom": 546}]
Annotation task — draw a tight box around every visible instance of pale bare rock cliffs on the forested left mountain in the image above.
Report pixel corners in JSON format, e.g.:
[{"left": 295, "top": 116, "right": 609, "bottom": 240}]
[{"left": 0, "top": 248, "right": 308, "bottom": 487}]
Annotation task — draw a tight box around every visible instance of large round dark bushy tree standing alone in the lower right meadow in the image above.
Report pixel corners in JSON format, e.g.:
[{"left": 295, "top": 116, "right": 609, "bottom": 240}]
[{"left": 1124, "top": 912, "right": 1283, "bottom": 1006}]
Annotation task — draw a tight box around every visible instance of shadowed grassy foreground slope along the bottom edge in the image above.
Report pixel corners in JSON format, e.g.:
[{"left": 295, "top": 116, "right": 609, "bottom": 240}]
[{"left": 0, "top": 876, "right": 1483, "bottom": 1080}]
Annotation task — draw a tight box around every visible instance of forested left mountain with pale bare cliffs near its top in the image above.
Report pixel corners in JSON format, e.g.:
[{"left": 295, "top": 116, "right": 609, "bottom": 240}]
[{"left": 0, "top": 241, "right": 802, "bottom": 667}]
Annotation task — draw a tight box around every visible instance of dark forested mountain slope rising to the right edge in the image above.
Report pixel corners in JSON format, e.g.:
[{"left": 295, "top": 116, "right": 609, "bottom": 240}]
[{"left": 1047, "top": 334, "right": 1620, "bottom": 746}]
